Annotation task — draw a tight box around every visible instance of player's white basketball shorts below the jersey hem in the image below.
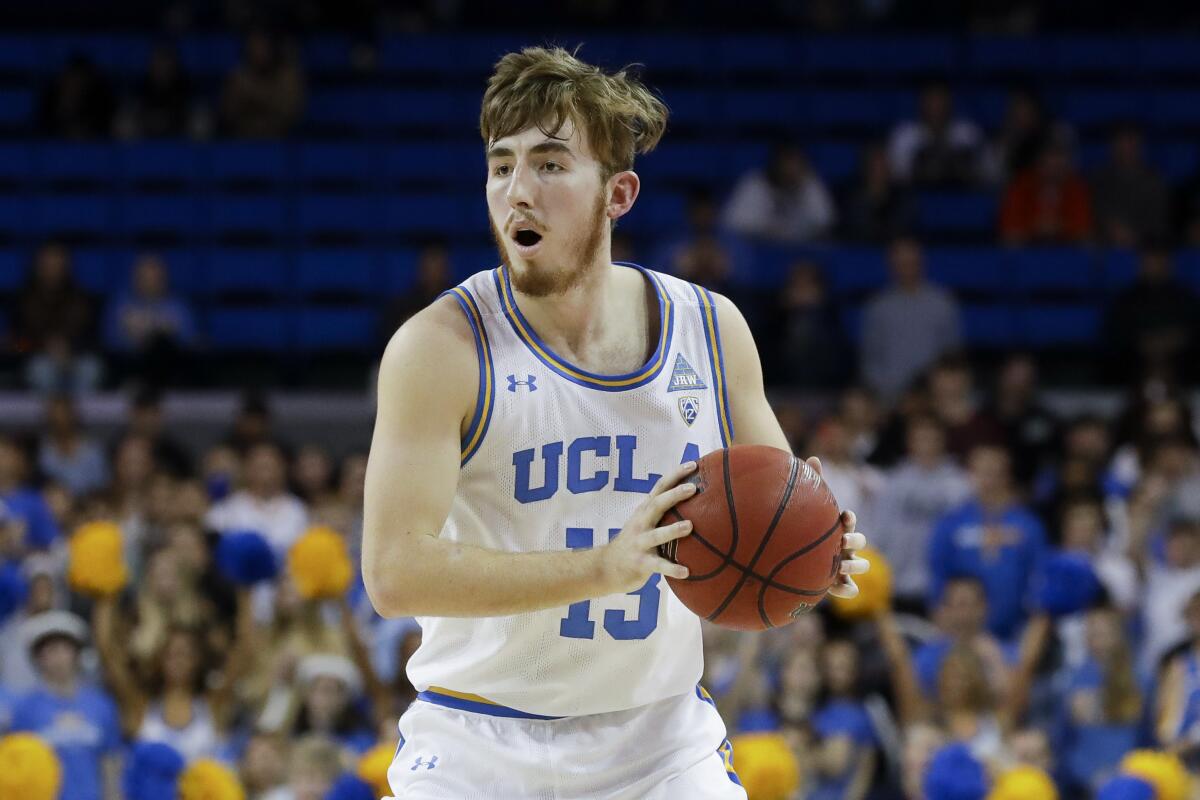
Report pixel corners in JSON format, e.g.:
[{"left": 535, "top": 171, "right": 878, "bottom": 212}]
[{"left": 388, "top": 686, "right": 746, "bottom": 800}]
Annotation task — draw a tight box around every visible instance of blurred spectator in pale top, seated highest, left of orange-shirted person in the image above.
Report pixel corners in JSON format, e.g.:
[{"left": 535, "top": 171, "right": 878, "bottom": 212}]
[{"left": 888, "top": 83, "right": 983, "bottom": 187}]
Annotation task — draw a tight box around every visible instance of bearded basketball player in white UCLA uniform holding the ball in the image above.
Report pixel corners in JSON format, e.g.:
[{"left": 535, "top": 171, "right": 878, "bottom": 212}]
[{"left": 362, "top": 48, "right": 866, "bottom": 800}]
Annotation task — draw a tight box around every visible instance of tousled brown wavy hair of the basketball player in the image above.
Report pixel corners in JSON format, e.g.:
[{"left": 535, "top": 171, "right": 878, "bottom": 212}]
[{"left": 479, "top": 47, "right": 667, "bottom": 181}]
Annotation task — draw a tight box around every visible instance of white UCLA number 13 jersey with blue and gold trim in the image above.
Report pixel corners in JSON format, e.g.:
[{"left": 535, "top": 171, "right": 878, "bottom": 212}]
[{"left": 408, "top": 265, "right": 733, "bottom": 717}]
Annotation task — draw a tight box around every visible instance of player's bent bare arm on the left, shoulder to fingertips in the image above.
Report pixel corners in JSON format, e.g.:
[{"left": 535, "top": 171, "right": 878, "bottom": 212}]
[{"left": 362, "top": 297, "right": 695, "bottom": 616}]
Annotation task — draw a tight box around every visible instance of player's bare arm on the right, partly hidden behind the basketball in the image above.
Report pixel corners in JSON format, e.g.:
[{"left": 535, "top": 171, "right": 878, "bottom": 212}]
[{"left": 713, "top": 294, "right": 870, "bottom": 597}]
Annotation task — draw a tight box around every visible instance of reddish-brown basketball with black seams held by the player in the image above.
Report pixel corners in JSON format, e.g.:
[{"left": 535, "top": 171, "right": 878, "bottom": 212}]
[{"left": 659, "top": 445, "right": 842, "bottom": 631}]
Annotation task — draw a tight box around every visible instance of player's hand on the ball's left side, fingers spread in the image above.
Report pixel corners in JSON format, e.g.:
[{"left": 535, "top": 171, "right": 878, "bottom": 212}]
[{"left": 598, "top": 461, "right": 696, "bottom": 595}]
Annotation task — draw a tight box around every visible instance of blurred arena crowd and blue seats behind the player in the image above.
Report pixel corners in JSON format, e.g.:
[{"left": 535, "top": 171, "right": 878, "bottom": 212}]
[{"left": 0, "top": 0, "right": 1200, "bottom": 800}]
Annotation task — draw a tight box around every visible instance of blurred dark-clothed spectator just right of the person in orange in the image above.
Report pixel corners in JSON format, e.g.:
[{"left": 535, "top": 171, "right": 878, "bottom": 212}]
[{"left": 1092, "top": 125, "right": 1170, "bottom": 247}]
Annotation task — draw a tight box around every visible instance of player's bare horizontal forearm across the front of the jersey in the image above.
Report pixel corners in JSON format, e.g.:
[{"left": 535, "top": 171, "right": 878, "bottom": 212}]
[{"left": 362, "top": 534, "right": 610, "bottom": 616}]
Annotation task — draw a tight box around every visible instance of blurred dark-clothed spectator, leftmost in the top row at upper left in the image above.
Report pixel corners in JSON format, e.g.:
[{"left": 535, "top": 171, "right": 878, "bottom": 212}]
[{"left": 37, "top": 53, "right": 116, "bottom": 139}]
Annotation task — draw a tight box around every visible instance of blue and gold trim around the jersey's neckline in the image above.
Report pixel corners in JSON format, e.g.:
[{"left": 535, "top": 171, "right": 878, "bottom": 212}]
[{"left": 492, "top": 261, "right": 674, "bottom": 392}]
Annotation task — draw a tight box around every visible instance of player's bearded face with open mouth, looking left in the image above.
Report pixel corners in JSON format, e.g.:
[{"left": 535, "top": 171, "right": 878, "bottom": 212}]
[{"left": 487, "top": 120, "right": 610, "bottom": 296}]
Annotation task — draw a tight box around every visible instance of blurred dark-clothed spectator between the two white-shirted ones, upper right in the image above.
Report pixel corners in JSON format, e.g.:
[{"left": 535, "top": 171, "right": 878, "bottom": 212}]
[{"left": 841, "top": 144, "right": 917, "bottom": 245}]
